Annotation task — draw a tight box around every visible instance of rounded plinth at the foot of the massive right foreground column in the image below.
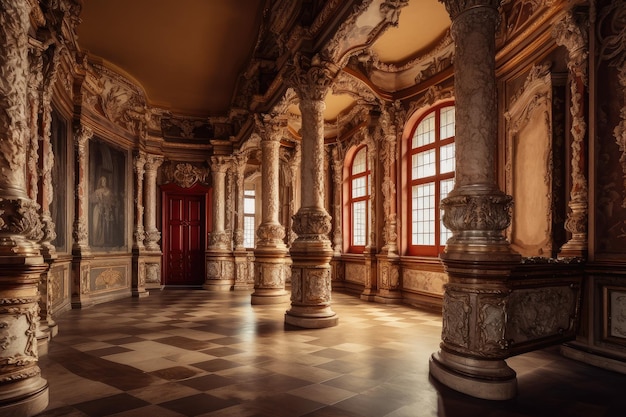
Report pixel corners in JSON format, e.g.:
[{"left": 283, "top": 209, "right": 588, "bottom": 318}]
[{"left": 429, "top": 351, "right": 517, "bottom": 400}]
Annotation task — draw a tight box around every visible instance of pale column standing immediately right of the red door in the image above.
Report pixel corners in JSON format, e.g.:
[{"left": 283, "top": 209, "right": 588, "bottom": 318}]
[{"left": 202, "top": 156, "right": 235, "bottom": 291}]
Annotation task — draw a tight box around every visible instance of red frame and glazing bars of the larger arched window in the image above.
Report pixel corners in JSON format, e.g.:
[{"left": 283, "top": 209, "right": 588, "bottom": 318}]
[{"left": 406, "top": 101, "right": 456, "bottom": 257}]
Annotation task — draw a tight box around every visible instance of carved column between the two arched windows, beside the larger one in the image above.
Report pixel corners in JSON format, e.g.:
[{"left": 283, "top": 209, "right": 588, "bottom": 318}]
[{"left": 375, "top": 107, "right": 403, "bottom": 303}]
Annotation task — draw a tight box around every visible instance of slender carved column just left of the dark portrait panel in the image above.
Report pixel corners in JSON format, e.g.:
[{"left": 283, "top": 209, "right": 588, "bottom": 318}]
[{"left": 72, "top": 122, "right": 93, "bottom": 308}]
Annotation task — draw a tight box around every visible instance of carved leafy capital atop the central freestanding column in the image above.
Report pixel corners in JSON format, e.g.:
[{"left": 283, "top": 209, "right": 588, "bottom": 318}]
[{"left": 286, "top": 54, "right": 337, "bottom": 101}]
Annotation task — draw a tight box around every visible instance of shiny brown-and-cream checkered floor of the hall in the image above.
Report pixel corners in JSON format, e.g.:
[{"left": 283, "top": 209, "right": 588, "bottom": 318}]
[{"left": 40, "top": 289, "right": 626, "bottom": 417}]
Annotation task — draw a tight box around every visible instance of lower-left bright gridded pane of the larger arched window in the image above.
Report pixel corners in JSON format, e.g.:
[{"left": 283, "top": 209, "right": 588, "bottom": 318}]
[{"left": 411, "top": 182, "right": 435, "bottom": 245}]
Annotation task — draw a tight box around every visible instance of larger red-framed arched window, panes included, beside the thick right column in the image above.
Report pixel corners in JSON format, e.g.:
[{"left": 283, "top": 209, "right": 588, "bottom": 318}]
[{"left": 407, "top": 103, "right": 455, "bottom": 256}]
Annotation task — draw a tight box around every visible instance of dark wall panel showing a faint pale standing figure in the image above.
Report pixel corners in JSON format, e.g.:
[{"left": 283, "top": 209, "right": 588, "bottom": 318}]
[{"left": 89, "top": 138, "right": 128, "bottom": 251}]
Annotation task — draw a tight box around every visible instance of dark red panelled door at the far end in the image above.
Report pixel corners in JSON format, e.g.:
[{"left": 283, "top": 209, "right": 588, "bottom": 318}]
[{"left": 163, "top": 184, "right": 206, "bottom": 285}]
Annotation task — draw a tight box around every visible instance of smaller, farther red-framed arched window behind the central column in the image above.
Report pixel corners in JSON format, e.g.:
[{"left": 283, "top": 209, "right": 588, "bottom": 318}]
[{"left": 347, "top": 146, "right": 371, "bottom": 253}]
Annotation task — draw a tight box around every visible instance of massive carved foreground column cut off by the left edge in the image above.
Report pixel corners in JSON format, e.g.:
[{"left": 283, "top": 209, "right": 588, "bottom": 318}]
[{"left": 0, "top": 0, "right": 48, "bottom": 416}]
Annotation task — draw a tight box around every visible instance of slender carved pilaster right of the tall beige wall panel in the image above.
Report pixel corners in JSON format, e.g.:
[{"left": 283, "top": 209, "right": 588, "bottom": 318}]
[{"left": 552, "top": 11, "right": 589, "bottom": 258}]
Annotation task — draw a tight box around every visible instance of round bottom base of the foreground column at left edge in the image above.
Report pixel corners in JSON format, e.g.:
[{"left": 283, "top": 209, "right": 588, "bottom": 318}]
[{"left": 0, "top": 377, "right": 49, "bottom": 417}]
